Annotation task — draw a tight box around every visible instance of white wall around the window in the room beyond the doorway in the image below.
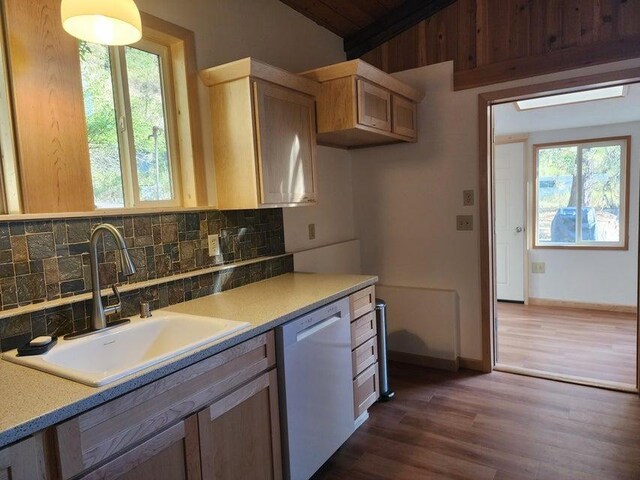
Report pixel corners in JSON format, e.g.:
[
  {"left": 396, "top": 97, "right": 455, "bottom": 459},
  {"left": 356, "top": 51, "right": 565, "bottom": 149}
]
[{"left": 527, "top": 122, "right": 640, "bottom": 305}]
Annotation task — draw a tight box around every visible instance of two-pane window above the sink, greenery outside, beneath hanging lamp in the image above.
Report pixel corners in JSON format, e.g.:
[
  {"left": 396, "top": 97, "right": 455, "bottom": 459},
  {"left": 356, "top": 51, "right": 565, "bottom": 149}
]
[{"left": 79, "top": 36, "right": 180, "bottom": 208}]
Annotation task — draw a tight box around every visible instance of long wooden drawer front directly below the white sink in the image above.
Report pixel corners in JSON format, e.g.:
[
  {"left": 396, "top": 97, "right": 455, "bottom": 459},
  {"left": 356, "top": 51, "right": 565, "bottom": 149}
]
[{"left": 55, "top": 332, "right": 275, "bottom": 479}]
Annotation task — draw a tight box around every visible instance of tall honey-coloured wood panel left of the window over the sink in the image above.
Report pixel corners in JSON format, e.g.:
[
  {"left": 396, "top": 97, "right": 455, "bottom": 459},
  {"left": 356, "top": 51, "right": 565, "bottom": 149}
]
[{"left": 3, "top": 0, "right": 94, "bottom": 213}]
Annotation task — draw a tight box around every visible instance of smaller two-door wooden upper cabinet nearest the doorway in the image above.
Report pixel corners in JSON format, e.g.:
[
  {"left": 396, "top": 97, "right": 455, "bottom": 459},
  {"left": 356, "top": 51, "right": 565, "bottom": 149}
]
[{"left": 301, "top": 60, "right": 424, "bottom": 148}]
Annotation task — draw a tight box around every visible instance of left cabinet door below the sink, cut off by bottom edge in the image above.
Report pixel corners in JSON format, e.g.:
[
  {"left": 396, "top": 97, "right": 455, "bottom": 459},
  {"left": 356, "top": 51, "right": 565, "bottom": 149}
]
[{"left": 81, "top": 415, "right": 201, "bottom": 480}]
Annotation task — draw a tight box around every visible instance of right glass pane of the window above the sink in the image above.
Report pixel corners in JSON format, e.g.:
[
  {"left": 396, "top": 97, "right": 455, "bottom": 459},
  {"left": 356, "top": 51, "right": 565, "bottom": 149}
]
[{"left": 125, "top": 47, "right": 174, "bottom": 202}]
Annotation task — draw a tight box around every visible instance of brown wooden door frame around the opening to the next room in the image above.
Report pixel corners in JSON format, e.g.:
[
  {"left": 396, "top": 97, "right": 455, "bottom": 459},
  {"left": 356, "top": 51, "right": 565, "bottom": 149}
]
[{"left": 478, "top": 68, "right": 640, "bottom": 387}]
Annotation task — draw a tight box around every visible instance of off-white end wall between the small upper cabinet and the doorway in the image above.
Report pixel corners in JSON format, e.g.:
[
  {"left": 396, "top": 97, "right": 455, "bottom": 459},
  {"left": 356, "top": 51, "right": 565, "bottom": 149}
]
[{"left": 352, "top": 59, "right": 640, "bottom": 359}]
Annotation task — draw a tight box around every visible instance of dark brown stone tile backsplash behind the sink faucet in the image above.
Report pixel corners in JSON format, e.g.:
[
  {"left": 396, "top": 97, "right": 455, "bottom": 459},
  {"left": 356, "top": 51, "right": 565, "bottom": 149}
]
[{"left": 0, "top": 209, "right": 293, "bottom": 350}]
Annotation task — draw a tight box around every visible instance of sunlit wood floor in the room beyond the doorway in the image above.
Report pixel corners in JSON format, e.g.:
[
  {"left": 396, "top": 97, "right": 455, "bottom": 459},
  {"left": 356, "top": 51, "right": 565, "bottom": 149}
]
[{"left": 497, "top": 302, "right": 636, "bottom": 386}]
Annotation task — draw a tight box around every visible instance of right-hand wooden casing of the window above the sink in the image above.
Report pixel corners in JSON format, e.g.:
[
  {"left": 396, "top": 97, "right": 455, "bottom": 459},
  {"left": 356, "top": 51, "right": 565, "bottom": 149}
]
[{"left": 140, "top": 12, "right": 208, "bottom": 207}]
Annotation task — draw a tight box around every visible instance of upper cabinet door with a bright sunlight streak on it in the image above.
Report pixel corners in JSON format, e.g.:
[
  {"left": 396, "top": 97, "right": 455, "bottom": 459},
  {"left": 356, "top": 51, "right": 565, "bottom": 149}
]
[{"left": 253, "top": 81, "right": 316, "bottom": 206}]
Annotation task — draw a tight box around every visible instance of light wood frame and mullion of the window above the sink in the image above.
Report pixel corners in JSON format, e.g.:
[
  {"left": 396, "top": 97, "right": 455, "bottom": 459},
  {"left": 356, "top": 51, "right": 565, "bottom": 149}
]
[{"left": 86, "top": 12, "right": 208, "bottom": 212}]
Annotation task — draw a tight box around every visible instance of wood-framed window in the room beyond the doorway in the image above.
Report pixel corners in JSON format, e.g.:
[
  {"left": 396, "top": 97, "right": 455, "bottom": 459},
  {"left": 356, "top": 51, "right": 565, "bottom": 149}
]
[{"left": 534, "top": 137, "right": 630, "bottom": 248}]
